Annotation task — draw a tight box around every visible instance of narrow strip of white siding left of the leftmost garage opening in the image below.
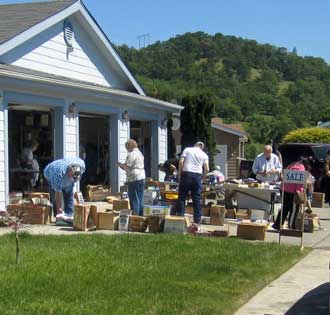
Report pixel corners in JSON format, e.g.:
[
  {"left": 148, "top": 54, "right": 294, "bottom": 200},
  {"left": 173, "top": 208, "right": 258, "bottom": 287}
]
[{"left": 0, "top": 95, "right": 6, "bottom": 210}]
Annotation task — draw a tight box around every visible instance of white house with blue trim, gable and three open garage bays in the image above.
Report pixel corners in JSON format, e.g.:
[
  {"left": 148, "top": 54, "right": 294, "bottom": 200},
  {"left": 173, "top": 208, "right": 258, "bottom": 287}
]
[{"left": 0, "top": 0, "right": 181, "bottom": 210}]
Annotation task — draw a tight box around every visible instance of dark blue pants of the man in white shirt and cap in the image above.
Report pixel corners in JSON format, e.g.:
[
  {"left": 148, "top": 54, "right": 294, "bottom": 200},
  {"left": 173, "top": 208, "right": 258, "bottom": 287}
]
[{"left": 178, "top": 172, "right": 202, "bottom": 224}]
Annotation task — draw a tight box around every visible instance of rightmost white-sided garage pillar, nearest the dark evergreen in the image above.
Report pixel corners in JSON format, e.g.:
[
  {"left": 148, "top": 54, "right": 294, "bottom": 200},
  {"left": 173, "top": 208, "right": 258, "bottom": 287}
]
[{"left": 151, "top": 120, "right": 167, "bottom": 180}]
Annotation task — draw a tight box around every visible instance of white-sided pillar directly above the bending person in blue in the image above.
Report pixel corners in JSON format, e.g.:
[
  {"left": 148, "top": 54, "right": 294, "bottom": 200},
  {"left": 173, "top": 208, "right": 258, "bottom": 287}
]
[{"left": 63, "top": 101, "right": 79, "bottom": 158}]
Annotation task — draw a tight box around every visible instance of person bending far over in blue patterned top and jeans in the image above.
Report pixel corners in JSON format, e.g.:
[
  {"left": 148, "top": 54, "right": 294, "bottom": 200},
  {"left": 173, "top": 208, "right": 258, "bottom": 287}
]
[{"left": 44, "top": 158, "right": 85, "bottom": 221}]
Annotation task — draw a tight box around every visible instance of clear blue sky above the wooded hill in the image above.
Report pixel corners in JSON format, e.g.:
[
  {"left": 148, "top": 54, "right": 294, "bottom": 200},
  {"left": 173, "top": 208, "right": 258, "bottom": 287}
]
[{"left": 0, "top": 0, "right": 330, "bottom": 63}]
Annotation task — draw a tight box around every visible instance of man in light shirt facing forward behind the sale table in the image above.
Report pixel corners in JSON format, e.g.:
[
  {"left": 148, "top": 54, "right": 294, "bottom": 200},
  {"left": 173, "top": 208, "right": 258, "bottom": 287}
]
[{"left": 252, "top": 145, "right": 282, "bottom": 182}]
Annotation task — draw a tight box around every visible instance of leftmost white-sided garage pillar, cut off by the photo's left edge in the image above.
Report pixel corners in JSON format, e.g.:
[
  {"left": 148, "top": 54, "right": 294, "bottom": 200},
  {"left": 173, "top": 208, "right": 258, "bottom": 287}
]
[{"left": 0, "top": 90, "right": 9, "bottom": 210}]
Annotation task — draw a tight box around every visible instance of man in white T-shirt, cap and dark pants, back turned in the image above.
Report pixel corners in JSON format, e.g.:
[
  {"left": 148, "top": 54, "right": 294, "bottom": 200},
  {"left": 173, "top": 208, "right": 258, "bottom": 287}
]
[{"left": 178, "top": 142, "right": 209, "bottom": 224}]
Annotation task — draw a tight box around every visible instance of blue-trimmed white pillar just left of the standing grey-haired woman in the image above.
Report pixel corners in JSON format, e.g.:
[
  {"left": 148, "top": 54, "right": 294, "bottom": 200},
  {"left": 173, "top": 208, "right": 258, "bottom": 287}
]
[{"left": 110, "top": 113, "right": 130, "bottom": 192}]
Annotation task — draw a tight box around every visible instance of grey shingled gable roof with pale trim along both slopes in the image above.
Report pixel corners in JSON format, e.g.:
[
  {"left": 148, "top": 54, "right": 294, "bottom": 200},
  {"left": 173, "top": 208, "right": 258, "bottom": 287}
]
[{"left": 0, "top": 0, "right": 146, "bottom": 95}]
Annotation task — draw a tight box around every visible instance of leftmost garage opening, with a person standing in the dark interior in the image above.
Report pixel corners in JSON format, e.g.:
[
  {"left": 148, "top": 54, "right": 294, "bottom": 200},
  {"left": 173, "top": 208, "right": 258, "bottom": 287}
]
[{"left": 8, "top": 105, "right": 54, "bottom": 192}]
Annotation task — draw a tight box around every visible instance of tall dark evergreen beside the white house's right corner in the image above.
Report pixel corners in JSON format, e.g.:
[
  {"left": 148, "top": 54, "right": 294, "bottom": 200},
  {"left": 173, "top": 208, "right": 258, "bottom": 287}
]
[{"left": 180, "top": 95, "right": 216, "bottom": 167}]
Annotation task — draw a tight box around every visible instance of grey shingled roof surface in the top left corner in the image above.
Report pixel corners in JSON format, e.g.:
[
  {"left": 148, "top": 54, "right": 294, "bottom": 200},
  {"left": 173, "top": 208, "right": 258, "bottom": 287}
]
[{"left": 0, "top": 0, "right": 78, "bottom": 45}]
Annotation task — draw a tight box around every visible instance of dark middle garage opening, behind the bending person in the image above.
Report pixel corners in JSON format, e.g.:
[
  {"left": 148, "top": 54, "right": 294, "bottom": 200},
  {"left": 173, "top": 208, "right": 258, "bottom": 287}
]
[{"left": 79, "top": 113, "right": 110, "bottom": 194}]
